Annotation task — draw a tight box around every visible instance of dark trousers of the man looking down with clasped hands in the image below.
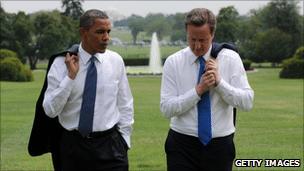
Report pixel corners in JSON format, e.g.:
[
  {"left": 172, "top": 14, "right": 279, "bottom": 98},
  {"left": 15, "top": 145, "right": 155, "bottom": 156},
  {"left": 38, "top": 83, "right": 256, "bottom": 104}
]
[{"left": 165, "top": 129, "right": 235, "bottom": 171}]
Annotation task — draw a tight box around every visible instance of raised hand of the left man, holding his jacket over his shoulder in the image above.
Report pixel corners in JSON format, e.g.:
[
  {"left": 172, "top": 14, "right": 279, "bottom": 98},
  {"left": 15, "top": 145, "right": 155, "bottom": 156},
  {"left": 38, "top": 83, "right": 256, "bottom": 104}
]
[{"left": 65, "top": 53, "right": 79, "bottom": 80}]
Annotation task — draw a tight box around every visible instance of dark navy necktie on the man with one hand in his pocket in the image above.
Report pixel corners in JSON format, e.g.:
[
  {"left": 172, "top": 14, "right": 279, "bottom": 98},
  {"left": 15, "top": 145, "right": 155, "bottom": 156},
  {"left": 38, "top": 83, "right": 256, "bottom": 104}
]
[{"left": 78, "top": 56, "right": 97, "bottom": 137}]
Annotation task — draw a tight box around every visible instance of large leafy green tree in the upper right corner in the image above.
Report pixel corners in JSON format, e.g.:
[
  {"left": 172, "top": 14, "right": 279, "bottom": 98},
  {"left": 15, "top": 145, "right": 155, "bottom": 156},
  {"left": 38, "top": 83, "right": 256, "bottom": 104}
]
[{"left": 237, "top": 0, "right": 304, "bottom": 62}]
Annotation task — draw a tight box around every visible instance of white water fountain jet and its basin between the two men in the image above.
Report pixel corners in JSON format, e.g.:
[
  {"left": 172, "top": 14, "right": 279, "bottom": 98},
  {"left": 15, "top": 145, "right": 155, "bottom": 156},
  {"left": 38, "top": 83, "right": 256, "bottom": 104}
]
[{"left": 126, "top": 32, "right": 162, "bottom": 75}]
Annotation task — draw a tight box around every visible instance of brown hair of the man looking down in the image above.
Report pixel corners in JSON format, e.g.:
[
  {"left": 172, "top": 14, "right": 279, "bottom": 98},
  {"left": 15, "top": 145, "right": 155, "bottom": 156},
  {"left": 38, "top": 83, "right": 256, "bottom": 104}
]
[{"left": 185, "top": 8, "right": 216, "bottom": 35}]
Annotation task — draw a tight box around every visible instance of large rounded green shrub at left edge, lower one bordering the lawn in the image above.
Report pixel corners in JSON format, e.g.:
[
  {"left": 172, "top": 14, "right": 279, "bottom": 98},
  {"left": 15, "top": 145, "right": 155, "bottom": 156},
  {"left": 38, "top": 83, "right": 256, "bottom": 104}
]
[{"left": 0, "top": 57, "right": 33, "bottom": 81}]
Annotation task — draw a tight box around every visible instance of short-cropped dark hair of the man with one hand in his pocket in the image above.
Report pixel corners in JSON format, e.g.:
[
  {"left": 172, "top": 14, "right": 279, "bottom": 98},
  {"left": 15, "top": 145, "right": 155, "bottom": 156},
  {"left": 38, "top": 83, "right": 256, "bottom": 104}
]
[{"left": 79, "top": 9, "right": 109, "bottom": 28}]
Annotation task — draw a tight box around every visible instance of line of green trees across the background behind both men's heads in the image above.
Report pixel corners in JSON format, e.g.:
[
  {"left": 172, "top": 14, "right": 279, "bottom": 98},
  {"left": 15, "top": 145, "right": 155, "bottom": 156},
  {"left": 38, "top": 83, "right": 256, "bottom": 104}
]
[{"left": 0, "top": 0, "right": 304, "bottom": 69}]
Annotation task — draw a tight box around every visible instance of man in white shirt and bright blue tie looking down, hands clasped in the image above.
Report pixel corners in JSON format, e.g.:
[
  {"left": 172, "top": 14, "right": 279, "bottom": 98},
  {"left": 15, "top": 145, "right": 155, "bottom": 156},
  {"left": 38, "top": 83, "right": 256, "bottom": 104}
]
[{"left": 160, "top": 8, "right": 254, "bottom": 171}]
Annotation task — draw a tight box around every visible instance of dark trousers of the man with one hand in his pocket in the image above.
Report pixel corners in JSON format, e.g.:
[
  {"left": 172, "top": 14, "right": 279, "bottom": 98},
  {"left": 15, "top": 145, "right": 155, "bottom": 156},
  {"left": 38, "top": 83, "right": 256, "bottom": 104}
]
[{"left": 60, "top": 128, "right": 129, "bottom": 171}]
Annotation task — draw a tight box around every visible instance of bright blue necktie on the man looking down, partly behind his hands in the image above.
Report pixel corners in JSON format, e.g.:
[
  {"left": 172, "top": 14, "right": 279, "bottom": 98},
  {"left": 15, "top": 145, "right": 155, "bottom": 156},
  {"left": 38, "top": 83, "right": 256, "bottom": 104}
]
[{"left": 197, "top": 56, "right": 212, "bottom": 145}]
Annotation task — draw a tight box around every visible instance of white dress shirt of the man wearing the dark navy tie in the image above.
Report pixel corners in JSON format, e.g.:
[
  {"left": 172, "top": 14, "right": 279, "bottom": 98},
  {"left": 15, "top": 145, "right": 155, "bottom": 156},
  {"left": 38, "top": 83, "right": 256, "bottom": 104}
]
[{"left": 43, "top": 45, "right": 134, "bottom": 147}]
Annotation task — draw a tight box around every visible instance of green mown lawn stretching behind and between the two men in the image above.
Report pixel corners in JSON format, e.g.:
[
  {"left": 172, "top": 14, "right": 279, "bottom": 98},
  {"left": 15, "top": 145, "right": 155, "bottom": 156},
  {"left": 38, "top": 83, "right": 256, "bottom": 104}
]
[{"left": 0, "top": 69, "right": 304, "bottom": 171}]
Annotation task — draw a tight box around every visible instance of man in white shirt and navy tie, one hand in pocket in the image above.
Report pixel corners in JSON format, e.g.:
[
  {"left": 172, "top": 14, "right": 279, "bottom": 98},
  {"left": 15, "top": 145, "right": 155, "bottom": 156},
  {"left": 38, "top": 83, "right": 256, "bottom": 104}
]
[{"left": 43, "top": 10, "right": 134, "bottom": 171}]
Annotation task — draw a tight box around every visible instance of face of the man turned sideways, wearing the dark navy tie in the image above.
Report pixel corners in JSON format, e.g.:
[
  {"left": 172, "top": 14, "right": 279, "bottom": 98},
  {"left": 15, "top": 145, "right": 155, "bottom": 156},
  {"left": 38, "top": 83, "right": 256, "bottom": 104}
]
[{"left": 81, "top": 18, "right": 111, "bottom": 54}]
